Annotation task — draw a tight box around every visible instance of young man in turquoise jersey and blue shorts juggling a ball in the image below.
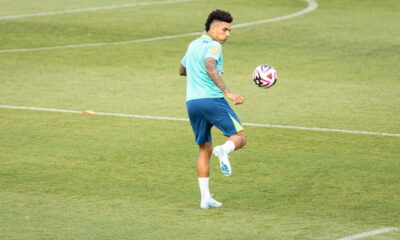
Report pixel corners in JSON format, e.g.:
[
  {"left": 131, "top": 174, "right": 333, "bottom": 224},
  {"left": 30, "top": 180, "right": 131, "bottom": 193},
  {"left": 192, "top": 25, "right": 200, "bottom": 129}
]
[{"left": 179, "top": 10, "right": 246, "bottom": 209}]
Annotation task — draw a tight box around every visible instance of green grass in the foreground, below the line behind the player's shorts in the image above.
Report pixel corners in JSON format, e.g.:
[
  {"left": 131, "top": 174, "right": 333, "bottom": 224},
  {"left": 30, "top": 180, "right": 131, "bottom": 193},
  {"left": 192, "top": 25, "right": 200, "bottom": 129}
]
[{"left": 0, "top": 110, "right": 400, "bottom": 239}]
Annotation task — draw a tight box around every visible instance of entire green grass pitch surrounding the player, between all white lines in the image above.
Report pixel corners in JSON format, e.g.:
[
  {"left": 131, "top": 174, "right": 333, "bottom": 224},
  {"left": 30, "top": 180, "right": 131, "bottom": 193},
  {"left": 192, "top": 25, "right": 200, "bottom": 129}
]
[{"left": 0, "top": 0, "right": 400, "bottom": 240}]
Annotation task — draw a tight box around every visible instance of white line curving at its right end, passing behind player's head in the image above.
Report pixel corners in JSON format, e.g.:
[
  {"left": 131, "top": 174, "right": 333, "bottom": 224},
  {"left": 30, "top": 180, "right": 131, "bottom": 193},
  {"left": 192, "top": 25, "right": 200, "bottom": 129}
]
[{"left": 0, "top": 0, "right": 318, "bottom": 53}]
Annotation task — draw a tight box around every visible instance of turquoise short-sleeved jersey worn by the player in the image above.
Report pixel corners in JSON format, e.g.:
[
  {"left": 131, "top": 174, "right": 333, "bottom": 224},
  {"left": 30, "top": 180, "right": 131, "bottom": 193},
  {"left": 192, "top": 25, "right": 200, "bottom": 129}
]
[{"left": 181, "top": 34, "right": 224, "bottom": 101}]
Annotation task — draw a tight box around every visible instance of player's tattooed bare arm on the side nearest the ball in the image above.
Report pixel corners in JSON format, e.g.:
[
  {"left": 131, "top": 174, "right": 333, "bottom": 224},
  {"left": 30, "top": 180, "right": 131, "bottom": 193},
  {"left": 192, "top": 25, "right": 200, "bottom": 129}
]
[{"left": 206, "top": 58, "right": 244, "bottom": 105}]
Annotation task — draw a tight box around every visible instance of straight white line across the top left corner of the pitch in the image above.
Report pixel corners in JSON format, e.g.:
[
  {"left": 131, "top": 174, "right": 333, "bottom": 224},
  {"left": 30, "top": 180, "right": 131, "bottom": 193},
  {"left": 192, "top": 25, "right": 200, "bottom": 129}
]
[{"left": 0, "top": 0, "right": 196, "bottom": 20}]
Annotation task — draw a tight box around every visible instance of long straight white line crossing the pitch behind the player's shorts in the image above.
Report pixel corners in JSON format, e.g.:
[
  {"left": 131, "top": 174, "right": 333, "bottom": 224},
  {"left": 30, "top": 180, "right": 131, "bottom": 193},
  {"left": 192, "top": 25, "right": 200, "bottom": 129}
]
[{"left": 0, "top": 105, "right": 400, "bottom": 137}]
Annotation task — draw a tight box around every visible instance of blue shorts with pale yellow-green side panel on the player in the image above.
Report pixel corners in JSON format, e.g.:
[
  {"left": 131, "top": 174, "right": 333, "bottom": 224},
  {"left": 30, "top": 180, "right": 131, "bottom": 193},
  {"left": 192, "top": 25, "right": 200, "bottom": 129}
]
[{"left": 186, "top": 98, "right": 243, "bottom": 144}]
